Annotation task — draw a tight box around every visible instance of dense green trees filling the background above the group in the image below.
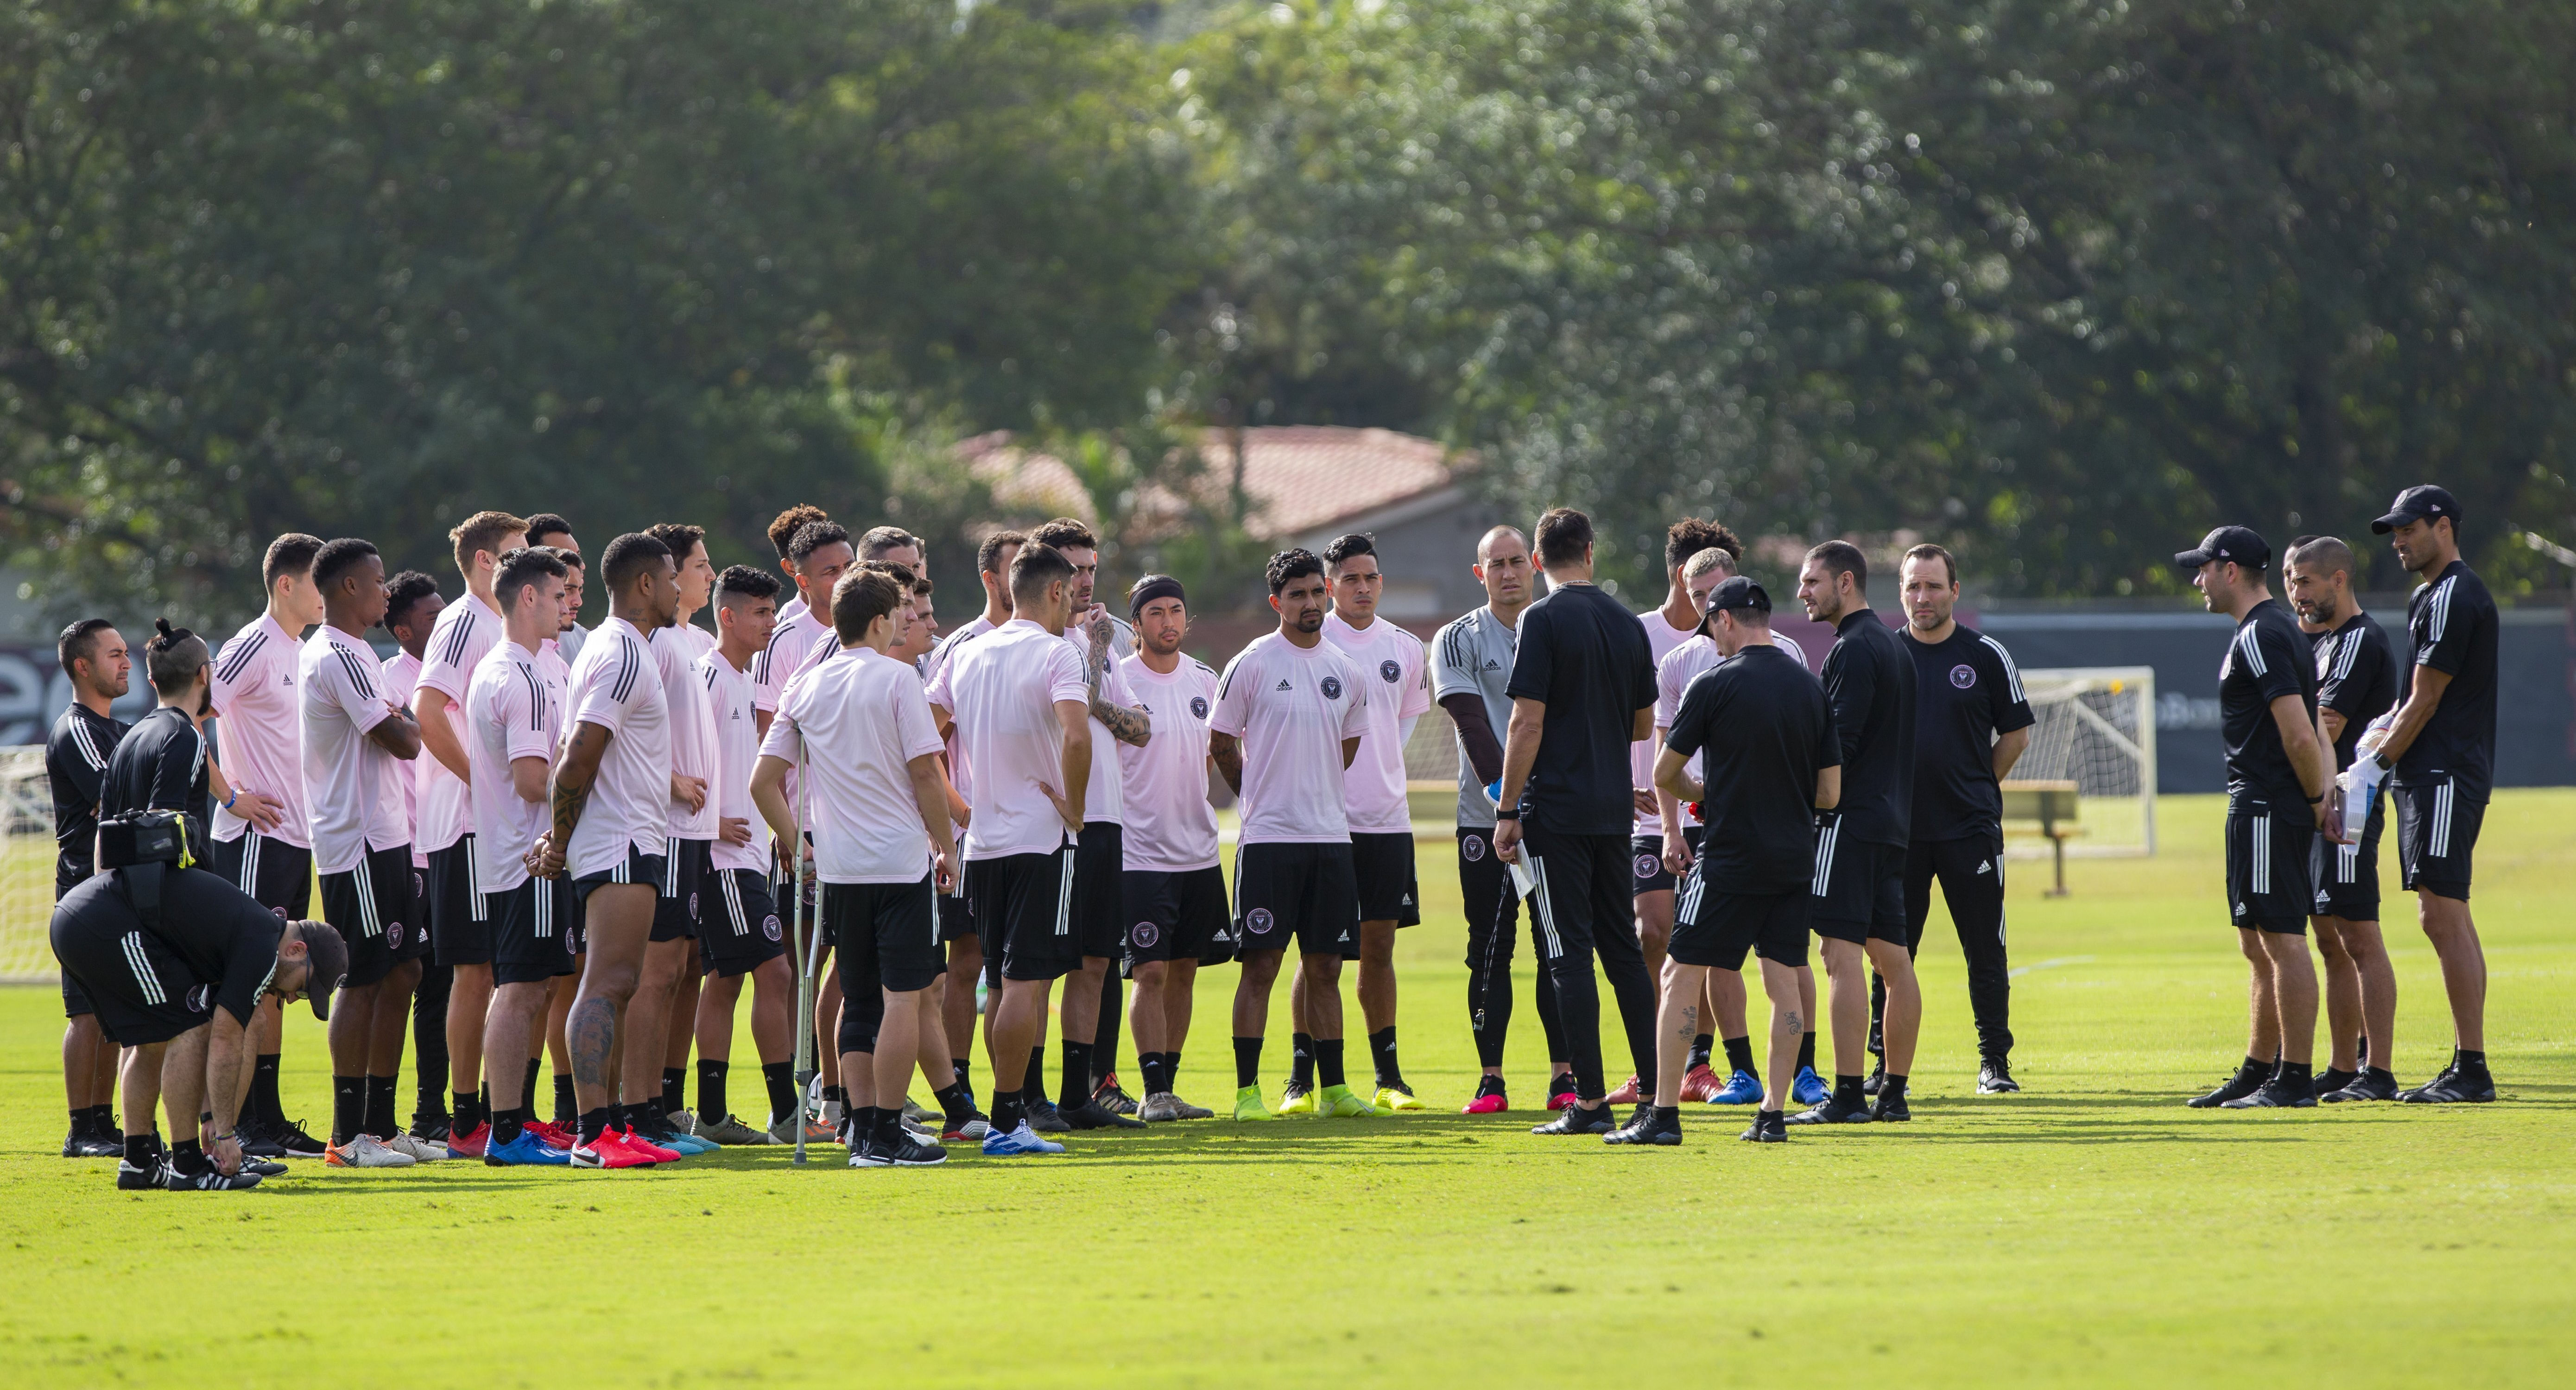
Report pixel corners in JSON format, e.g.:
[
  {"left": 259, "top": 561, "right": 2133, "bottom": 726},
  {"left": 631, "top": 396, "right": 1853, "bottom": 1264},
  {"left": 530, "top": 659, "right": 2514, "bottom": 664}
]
[{"left": 0, "top": 0, "right": 2576, "bottom": 618}]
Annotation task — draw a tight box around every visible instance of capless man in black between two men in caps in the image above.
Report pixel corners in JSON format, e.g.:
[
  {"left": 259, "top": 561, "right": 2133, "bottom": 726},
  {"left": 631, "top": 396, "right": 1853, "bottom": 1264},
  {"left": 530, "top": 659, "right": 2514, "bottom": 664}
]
[{"left": 2280, "top": 536, "right": 2398, "bottom": 1102}]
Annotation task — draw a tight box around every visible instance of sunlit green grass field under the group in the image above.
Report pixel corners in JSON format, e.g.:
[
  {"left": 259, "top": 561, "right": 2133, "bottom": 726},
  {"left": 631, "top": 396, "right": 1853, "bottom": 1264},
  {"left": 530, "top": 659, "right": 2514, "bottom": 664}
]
[{"left": 0, "top": 790, "right": 2576, "bottom": 1387}]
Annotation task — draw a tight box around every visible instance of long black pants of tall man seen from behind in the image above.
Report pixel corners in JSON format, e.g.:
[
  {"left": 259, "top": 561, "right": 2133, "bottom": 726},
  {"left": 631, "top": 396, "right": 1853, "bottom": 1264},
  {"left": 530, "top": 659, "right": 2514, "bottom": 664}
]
[{"left": 1520, "top": 826, "right": 1654, "bottom": 1099}]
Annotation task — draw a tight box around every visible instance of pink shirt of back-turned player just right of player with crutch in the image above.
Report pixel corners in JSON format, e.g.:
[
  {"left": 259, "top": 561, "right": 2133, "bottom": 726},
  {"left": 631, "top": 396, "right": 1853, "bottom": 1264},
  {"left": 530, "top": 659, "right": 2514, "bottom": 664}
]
[{"left": 940, "top": 618, "right": 1089, "bottom": 860}]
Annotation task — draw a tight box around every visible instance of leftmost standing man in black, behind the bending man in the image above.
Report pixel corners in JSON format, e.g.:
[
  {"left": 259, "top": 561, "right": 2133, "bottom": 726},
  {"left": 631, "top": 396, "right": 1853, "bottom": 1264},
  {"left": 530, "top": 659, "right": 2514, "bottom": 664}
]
[{"left": 44, "top": 618, "right": 134, "bottom": 1158}]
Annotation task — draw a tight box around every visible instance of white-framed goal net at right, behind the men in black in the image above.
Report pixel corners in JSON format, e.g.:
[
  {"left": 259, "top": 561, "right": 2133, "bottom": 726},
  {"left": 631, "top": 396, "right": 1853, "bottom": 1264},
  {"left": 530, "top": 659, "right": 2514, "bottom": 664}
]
[{"left": 2004, "top": 667, "right": 2156, "bottom": 857}]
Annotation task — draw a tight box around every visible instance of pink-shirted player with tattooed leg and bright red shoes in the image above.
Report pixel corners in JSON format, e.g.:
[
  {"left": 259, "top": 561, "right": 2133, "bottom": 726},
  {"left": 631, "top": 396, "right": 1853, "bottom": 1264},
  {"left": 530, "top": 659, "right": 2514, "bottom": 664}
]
[{"left": 538, "top": 533, "right": 680, "bottom": 1169}]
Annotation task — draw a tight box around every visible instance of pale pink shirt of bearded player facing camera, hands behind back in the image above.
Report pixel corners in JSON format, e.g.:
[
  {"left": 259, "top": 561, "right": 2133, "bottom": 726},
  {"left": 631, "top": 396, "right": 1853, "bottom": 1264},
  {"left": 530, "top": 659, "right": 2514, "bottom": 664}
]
[{"left": 1208, "top": 633, "right": 1378, "bottom": 844}]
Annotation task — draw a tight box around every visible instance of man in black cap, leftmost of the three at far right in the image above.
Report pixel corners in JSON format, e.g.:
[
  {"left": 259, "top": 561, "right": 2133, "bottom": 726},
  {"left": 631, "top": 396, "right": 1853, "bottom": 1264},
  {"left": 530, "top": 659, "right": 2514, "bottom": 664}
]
[{"left": 2174, "top": 525, "right": 2331, "bottom": 1109}]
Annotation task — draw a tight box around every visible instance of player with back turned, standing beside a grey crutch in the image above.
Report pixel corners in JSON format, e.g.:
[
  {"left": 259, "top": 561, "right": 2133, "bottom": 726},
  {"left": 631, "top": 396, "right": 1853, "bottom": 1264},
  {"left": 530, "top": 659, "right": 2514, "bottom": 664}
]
[{"left": 752, "top": 564, "right": 956, "bottom": 1169}]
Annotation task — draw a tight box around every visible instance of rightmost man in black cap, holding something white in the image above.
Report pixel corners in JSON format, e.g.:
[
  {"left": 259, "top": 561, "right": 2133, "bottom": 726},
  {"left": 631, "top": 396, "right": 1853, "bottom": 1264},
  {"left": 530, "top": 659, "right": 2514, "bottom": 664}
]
[{"left": 2370, "top": 486, "right": 2496, "bottom": 1104}]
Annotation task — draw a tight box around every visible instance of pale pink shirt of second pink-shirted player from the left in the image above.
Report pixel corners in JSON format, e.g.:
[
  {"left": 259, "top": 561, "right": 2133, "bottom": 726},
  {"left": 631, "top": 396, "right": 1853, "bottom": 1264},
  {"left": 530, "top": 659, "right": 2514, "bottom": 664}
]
[{"left": 296, "top": 623, "right": 412, "bottom": 872}]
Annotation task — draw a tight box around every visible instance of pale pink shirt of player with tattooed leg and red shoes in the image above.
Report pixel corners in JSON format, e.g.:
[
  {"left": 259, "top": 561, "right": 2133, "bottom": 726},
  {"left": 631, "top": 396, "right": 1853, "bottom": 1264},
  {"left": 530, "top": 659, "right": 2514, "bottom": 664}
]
[{"left": 564, "top": 615, "right": 670, "bottom": 878}]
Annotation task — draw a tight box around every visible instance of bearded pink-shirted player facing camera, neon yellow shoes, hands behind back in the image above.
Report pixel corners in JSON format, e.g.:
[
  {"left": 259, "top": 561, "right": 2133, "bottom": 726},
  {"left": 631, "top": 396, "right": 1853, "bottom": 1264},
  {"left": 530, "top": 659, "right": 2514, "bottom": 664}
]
[{"left": 1208, "top": 551, "right": 1376, "bottom": 1120}]
